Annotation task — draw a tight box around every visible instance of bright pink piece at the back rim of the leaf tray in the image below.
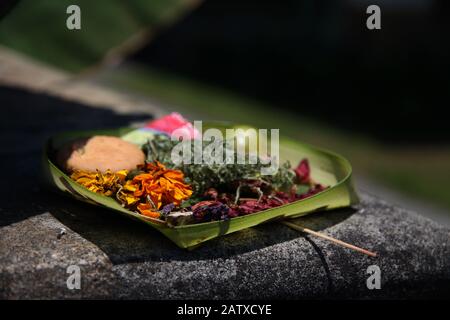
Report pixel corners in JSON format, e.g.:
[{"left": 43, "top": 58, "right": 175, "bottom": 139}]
[{"left": 145, "top": 112, "right": 200, "bottom": 139}]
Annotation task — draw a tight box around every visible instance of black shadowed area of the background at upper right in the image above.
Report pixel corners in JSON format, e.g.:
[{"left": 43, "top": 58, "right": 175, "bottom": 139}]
[{"left": 132, "top": 0, "right": 450, "bottom": 143}]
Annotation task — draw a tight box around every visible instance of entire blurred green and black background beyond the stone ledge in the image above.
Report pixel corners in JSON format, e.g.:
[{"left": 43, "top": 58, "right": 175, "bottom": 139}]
[{"left": 0, "top": 0, "right": 450, "bottom": 215}]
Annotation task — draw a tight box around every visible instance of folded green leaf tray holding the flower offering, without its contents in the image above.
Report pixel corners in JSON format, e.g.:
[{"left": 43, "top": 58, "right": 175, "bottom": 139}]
[{"left": 44, "top": 123, "right": 358, "bottom": 248}]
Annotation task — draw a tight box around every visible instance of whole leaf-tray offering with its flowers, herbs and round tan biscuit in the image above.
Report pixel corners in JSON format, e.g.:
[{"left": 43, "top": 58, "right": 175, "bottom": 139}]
[{"left": 44, "top": 114, "right": 358, "bottom": 250}]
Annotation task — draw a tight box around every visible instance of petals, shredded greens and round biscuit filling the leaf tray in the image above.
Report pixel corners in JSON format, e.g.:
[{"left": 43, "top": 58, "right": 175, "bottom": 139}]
[{"left": 57, "top": 114, "right": 327, "bottom": 226}]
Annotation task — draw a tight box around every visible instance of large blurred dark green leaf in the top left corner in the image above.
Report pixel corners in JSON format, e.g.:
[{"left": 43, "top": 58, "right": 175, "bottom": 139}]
[{"left": 0, "top": 0, "right": 190, "bottom": 71}]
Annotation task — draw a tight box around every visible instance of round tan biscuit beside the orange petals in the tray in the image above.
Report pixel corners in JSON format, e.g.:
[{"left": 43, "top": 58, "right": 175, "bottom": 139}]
[{"left": 57, "top": 136, "right": 145, "bottom": 172}]
